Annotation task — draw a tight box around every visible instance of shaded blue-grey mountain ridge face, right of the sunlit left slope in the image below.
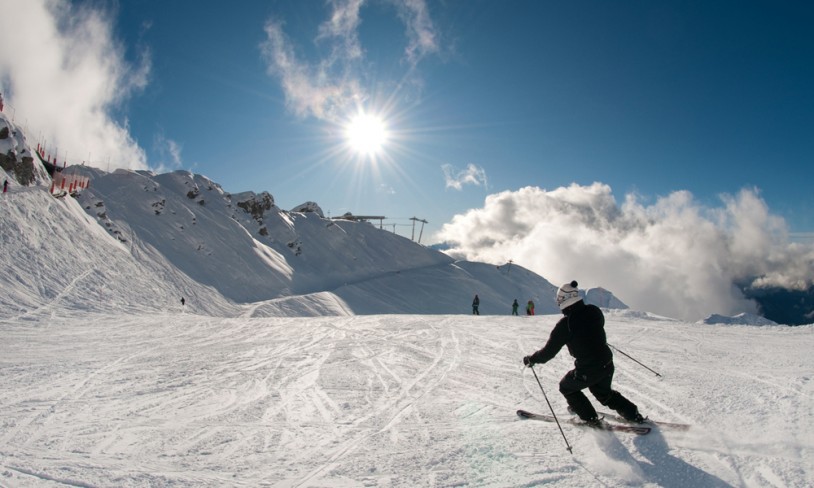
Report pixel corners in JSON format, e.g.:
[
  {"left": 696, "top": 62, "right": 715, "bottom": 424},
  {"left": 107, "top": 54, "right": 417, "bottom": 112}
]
[{"left": 68, "top": 168, "right": 568, "bottom": 315}]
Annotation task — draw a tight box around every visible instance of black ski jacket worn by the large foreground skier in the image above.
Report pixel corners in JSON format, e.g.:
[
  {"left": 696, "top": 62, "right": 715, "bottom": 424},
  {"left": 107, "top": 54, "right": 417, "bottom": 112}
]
[{"left": 531, "top": 300, "right": 613, "bottom": 369}]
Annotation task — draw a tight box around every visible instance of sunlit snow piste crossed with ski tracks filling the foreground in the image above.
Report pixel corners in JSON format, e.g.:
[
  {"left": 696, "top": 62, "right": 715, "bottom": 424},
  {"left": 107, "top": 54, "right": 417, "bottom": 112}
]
[{"left": 0, "top": 308, "right": 814, "bottom": 487}]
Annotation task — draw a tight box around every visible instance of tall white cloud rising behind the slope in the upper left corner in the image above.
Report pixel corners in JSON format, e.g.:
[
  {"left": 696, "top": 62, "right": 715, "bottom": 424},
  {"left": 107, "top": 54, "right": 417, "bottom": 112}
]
[{"left": 0, "top": 0, "right": 150, "bottom": 169}]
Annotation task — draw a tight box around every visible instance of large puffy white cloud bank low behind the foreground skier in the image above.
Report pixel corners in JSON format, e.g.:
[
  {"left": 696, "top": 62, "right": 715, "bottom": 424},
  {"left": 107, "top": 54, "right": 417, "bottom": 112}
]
[{"left": 439, "top": 183, "right": 814, "bottom": 320}]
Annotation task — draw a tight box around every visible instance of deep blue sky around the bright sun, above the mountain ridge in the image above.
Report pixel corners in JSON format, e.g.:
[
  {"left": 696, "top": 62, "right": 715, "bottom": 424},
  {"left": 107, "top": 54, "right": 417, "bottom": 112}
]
[{"left": 0, "top": 0, "right": 814, "bottom": 248}]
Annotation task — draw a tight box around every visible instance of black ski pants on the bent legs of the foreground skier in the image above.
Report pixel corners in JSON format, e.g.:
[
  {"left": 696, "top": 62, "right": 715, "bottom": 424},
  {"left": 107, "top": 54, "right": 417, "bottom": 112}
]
[{"left": 560, "top": 361, "right": 639, "bottom": 420}]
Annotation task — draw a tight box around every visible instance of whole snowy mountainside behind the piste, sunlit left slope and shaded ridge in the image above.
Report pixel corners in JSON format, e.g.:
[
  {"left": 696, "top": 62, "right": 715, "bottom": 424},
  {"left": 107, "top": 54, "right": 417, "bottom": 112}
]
[{"left": 0, "top": 105, "right": 576, "bottom": 316}]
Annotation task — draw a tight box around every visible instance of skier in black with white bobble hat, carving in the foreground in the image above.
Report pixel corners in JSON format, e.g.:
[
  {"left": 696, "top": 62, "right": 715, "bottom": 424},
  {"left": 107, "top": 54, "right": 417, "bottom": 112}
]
[{"left": 523, "top": 281, "right": 646, "bottom": 427}]
